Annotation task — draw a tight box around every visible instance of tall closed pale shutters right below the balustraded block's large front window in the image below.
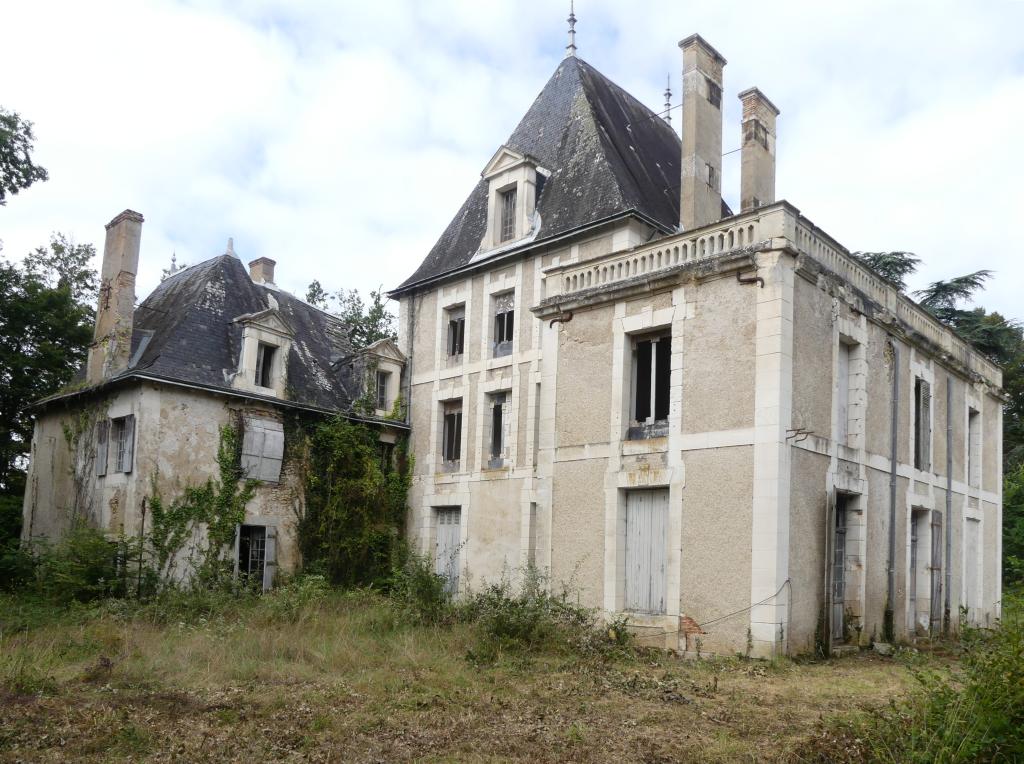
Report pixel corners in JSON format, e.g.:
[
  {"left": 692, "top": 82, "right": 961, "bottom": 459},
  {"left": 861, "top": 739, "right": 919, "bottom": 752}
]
[{"left": 625, "top": 490, "right": 669, "bottom": 613}]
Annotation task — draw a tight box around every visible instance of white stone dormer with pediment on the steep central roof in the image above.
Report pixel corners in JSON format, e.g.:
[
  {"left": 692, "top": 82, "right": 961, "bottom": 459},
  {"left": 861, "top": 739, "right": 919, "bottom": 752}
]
[{"left": 480, "top": 145, "right": 545, "bottom": 252}]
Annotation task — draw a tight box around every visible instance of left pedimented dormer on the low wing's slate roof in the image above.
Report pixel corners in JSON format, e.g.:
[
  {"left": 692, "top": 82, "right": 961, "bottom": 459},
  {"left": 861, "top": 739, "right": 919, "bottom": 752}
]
[{"left": 231, "top": 306, "right": 295, "bottom": 398}]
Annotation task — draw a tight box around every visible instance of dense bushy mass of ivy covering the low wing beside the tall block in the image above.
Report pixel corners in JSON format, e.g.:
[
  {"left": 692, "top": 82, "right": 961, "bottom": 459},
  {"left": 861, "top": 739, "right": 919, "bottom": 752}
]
[{"left": 299, "top": 416, "right": 409, "bottom": 586}]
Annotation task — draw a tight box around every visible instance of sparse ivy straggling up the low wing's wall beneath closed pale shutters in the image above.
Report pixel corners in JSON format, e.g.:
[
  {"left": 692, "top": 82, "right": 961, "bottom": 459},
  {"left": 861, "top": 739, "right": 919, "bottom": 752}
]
[{"left": 147, "top": 425, "right": 256, "bottom": 587}]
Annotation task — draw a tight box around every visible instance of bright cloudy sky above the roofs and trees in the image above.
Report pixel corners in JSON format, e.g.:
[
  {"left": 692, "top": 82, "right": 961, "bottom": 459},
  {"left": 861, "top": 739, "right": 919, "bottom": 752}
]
[{"left": 0, "top": 0, "right": 1024, "bottom": 319}]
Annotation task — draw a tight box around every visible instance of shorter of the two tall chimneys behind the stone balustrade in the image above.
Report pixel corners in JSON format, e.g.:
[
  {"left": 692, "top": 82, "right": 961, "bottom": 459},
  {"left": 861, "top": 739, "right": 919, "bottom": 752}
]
[{"left": 739, "top": 87, "right": 778, "bottom": 212}]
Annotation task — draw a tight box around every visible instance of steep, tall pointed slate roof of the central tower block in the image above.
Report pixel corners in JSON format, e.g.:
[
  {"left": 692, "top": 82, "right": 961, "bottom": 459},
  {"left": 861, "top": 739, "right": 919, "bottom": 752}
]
[{"left": 395, "top": 56, "right": 732, "bottom": 293}]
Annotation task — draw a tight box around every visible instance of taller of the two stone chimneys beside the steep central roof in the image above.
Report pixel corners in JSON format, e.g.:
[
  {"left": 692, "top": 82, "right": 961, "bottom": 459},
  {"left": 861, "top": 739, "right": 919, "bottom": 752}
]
[{"left": 679, "top": 35, "right": 725, "bottom": 230}]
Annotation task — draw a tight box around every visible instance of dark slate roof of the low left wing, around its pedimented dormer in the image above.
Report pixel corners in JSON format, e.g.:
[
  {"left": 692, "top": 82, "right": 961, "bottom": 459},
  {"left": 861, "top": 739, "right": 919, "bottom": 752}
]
[{"left": 112, "top": 255, "right": 358, "bottom": 410}]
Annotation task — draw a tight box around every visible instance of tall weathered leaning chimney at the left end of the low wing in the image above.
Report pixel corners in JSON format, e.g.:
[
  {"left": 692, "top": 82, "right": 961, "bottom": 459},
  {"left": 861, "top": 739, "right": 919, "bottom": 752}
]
[{"left": 86, "top": 210, "right": 143, "bottom": 384}]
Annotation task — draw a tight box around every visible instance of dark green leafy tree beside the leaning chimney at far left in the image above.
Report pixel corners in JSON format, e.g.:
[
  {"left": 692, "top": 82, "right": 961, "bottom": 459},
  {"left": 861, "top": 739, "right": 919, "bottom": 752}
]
[{"left": 0, "top": 235, "right": 97, "bottom": 493}]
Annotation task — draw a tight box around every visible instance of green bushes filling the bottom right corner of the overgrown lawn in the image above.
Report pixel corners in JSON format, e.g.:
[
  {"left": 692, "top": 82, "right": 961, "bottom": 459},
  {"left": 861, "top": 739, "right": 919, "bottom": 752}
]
[{"left": 820, "top": 597, "right": 1024, "bottom": 764}]
